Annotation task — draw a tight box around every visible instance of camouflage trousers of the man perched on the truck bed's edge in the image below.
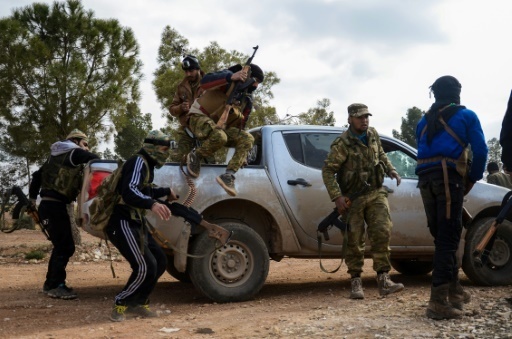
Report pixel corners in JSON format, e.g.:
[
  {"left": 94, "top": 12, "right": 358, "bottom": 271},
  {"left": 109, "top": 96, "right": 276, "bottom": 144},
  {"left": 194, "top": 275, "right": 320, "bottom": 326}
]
[{"left": 188, "top": 114, "right": 254, "bottom": 172}]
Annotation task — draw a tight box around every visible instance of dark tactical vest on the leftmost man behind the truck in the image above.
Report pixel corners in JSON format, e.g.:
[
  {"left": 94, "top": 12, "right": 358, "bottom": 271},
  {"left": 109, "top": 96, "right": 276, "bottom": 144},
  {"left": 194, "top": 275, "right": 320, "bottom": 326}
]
[{"left": 41, "top": 151, "right": 84, "bottom": 201}]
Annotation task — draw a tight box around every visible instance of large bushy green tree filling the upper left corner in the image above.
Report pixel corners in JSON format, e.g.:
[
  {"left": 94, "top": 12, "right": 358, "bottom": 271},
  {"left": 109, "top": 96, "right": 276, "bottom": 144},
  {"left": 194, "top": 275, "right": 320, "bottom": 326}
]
[{"left": 0, "top": 0, "right": 142, "bottom": 169}]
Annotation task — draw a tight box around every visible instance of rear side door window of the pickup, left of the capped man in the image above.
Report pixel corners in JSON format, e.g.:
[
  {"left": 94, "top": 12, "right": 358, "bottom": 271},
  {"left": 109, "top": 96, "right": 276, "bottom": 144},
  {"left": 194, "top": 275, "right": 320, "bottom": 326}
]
[{"left": 283, "top": 132, "right": 338, "bottom": 169}]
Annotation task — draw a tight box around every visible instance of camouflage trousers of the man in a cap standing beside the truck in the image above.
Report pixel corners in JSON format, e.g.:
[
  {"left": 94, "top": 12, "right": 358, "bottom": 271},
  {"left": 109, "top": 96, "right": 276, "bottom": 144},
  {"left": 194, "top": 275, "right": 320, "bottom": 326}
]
[{"left": 345, "top": 188, "right": 393, "bottom": 275}]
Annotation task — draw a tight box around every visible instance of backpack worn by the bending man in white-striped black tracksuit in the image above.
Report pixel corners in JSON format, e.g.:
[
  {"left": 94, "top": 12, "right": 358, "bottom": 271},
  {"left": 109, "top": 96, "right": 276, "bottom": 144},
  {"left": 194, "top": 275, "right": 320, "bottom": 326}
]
[{"left": 89, "top": 160, "right": 123, "bottom": 231}]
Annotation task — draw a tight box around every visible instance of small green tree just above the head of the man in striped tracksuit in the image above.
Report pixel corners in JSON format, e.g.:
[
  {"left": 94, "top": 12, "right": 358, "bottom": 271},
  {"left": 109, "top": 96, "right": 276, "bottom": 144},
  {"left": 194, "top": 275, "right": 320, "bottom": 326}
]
[{"left": 114, "top": 103, "right": 153, "bottom": 160}]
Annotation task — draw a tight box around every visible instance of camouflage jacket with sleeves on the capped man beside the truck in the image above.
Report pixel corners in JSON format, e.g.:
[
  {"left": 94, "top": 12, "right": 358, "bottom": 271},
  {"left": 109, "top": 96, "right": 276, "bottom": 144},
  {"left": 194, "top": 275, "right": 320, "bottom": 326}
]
[{"left": 322, "top": 127, "right": 395, "bottom": 201}]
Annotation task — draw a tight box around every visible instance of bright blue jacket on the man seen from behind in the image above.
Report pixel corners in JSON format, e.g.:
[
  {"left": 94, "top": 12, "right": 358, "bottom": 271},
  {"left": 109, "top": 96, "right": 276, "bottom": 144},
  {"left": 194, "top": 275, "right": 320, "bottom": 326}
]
[{"left": 416, "top": 108, "right": 488, "bottom": 182}]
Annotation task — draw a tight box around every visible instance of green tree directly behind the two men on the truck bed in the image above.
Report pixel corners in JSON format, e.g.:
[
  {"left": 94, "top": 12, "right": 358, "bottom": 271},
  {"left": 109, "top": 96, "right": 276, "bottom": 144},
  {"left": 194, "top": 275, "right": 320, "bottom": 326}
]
[{"left": 153, "top": 26, "right": 280, "bottom": 135}]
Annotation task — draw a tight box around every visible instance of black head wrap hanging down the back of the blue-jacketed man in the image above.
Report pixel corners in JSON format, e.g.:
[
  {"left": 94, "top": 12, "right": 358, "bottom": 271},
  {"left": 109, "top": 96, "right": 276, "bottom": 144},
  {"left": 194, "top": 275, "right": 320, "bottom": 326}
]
[{"left": 425, "top": 75, "right": 464, "bottom": 145}]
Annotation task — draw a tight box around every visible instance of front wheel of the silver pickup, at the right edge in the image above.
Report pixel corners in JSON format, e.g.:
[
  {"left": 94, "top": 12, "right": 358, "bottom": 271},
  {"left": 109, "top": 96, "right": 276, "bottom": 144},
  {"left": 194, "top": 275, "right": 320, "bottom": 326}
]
[{"left": 462, "top": 218, "right": 512, "bottom": 286}]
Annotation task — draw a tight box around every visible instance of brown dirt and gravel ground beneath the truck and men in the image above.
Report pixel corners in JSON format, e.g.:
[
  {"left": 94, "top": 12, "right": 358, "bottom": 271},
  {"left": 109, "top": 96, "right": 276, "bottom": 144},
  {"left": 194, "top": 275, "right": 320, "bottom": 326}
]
[{"left": 0, "top": 230, "right": 512, "bottom": 338}]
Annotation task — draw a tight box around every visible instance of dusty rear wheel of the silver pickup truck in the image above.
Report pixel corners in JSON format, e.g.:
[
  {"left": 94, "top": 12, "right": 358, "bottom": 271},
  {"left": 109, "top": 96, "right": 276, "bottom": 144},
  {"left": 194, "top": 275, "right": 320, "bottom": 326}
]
[{"left": 189, "top": 223, "right": 269, "bottom": 302}]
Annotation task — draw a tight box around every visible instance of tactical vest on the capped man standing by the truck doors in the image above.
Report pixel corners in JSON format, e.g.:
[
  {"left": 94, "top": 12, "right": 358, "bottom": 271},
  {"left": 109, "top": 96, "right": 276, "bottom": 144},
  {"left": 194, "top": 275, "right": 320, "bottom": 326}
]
[{"left": 334, "top": 130, "right": 385, "bottom": 194}]
